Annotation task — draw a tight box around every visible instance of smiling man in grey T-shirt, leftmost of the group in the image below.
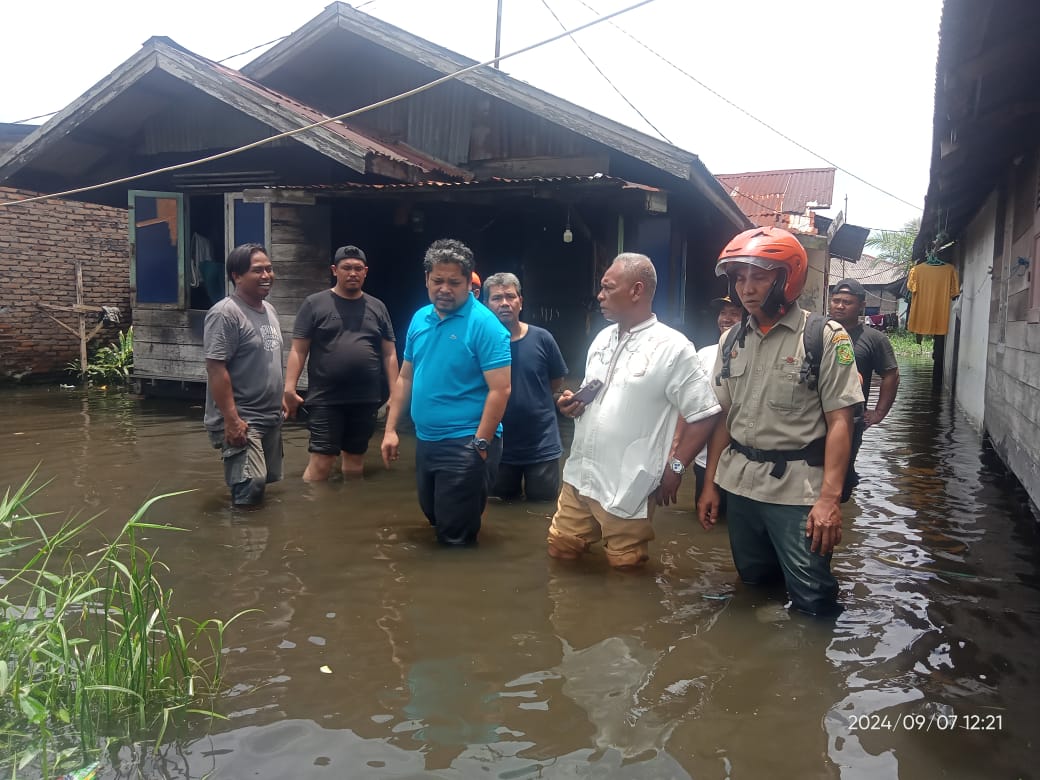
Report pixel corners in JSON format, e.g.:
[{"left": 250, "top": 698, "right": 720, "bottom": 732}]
[{"left": 203, "top": 243, "right": 284, "bottom": 506}]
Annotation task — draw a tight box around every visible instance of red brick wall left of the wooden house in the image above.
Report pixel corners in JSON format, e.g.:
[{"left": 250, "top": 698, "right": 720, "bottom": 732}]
[{"left": 0, "top": 187, "right": 130, "bottom": 382}]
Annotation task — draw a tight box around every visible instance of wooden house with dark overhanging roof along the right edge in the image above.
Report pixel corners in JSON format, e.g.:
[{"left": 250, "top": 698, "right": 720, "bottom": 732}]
[{"left": 914, "top": 0, "right": 1040, "bottom": 504}]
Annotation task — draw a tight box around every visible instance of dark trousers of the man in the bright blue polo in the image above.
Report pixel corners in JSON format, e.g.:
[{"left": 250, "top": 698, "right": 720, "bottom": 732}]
[{"left": 415, "top": 436, "right": 502, "bottom": 546}]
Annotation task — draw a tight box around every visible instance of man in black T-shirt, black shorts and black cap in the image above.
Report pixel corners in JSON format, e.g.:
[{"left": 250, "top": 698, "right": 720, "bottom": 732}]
[{"left": 285, "top": 245, "right": 397, "bottom": 482}]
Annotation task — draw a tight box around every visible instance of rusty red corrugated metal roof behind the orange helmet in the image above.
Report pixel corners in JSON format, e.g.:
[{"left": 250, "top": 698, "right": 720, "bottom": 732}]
[{"left": 716, "top": 167, "right": 834, "bottom": 225}]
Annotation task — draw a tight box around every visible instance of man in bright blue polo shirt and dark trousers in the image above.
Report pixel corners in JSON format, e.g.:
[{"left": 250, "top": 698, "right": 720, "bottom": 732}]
[{"left": 382, "top": 238, "right": 511, "bottom": 545}]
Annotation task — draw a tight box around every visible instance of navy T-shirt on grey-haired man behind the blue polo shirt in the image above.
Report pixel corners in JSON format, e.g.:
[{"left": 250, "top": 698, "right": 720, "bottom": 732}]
[{"left": 502, "top": 326, "right": 567, "bottom": 467}]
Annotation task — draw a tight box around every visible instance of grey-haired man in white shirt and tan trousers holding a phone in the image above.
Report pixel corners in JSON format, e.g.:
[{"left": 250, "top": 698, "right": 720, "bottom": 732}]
[{"left": 548, "top": 253, "right": 722, "bottom": 569}]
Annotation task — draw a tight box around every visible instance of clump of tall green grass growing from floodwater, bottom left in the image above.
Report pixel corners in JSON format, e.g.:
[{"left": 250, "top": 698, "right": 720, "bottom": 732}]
[{"left": 0, "top": 473, "right": 243, "bottom": 778}]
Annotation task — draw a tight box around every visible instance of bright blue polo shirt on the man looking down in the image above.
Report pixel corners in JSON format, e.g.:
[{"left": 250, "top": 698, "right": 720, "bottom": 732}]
[{"left": 405, "top": 295, "right": 512, "bottom": 441}]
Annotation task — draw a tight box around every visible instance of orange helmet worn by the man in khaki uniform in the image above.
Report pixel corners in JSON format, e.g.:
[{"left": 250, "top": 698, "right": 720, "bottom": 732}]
[{"left": 716, "top": 228, "right": 809, "bottom": 311}]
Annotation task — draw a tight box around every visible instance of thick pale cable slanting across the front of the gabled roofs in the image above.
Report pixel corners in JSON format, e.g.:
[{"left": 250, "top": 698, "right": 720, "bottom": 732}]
[{"left": 0, "top": 0, "right": 655, "bottom": 208}]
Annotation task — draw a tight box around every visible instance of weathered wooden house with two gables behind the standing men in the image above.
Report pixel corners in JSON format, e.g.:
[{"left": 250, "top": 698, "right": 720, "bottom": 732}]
[{"left": 0, "top": 3, "right": 750, "bottom": 392}]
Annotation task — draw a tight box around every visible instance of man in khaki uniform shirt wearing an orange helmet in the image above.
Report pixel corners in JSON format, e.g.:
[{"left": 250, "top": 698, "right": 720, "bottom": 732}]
[{"left": 698, "top": 228, "right": 863, "bottom": 616}]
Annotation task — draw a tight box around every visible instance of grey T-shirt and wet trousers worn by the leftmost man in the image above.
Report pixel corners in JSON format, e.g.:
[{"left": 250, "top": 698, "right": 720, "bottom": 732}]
[{"left": 203, "top": 295, "right": 284, "bottom": 506}]
